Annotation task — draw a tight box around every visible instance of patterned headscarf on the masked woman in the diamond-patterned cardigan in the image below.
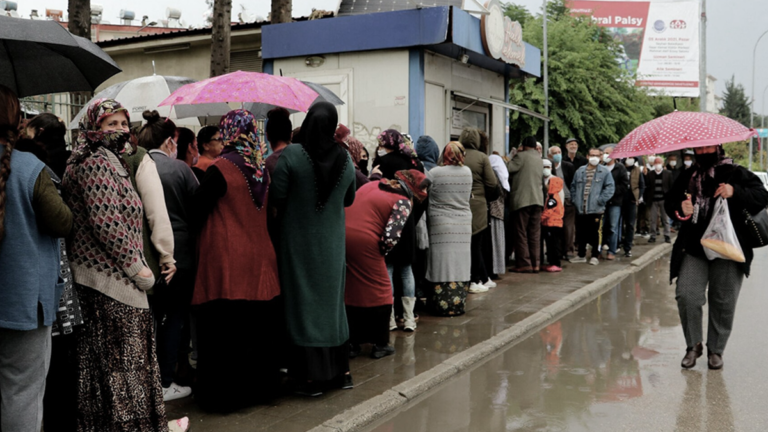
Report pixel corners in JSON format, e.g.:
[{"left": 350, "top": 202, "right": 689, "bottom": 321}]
[{"left": 68, "top": 99, "right": 131, "bottom": 164}]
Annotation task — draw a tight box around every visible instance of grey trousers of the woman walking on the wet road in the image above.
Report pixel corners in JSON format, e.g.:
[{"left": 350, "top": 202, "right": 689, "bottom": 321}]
[{"left": 675, "top": 254, "right": 744, "bottom": 355}]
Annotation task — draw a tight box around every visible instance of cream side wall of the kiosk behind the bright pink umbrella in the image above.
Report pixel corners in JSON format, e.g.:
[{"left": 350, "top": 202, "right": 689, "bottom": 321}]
[{"left": 273, "top": 50, "right": 409, "bottom": 155}]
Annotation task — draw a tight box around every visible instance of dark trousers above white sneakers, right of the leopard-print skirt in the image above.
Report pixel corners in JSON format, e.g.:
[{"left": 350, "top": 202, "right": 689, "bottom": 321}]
[{"left": 151, "top": 269, "right": 195, "bottom": 388}]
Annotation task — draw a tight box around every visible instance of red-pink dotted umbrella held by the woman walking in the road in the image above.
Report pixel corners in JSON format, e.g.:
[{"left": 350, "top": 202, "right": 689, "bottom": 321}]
[{"left": 611, "top": 111, "right": 757, "bottom": 158}]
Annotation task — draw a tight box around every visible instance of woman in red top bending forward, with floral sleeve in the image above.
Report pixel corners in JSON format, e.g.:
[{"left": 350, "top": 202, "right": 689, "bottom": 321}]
[{"left": 344, "top": 170, "right": 429, "bottom": 358}]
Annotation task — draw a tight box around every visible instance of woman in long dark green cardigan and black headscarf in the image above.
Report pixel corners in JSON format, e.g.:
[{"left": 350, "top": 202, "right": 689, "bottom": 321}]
[{"left": 269, "top": 102, "right": 355, "bottom": 396}]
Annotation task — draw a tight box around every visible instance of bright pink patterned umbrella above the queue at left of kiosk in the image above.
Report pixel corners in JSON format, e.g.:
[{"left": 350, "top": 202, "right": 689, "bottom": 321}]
[{"left": 159, "top": 71, "right": 318, "bottom": 114}]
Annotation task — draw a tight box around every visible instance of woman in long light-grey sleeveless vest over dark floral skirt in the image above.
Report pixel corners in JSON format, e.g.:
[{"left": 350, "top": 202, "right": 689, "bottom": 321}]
[{"left": 426, "top": 141, "right": 472, "bottom": 316}]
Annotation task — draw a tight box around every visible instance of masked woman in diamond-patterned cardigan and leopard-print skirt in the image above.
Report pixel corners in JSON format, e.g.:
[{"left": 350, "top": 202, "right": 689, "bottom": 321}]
[{"left": 62, "top": 99, "right": 174, "bottom": 432}]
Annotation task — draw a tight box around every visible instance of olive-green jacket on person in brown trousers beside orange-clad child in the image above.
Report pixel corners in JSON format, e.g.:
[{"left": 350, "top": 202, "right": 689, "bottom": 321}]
[{"left": 508, "top": 149, "right": 544, "bottom": 211}]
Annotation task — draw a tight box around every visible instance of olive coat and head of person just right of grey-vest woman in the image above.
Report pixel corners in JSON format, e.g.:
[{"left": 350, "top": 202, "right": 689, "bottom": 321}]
[{"left": 459, "top": 128, "right": 499, "bottom": 235}]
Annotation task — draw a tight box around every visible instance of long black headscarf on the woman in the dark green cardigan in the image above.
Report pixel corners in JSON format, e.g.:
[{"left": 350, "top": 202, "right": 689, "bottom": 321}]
[{"left": 293, "top": 102, "right": 350, "bottom": 211}]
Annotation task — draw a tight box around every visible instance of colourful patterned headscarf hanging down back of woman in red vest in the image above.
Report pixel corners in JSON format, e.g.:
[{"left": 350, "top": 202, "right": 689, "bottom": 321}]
[{"left": 219, "top": 109, "right": 269, "bottom": 210}]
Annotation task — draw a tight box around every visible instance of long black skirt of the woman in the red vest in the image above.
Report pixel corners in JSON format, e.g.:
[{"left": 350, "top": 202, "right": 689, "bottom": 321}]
[{"left": 193, "top": 298, "right": 285, "bottom": 412}]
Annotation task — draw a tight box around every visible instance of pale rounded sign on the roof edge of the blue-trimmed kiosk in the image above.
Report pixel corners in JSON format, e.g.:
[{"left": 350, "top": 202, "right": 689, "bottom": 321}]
[{"left": 480, "top": 0, "right": 525, "bottom": 67}]
